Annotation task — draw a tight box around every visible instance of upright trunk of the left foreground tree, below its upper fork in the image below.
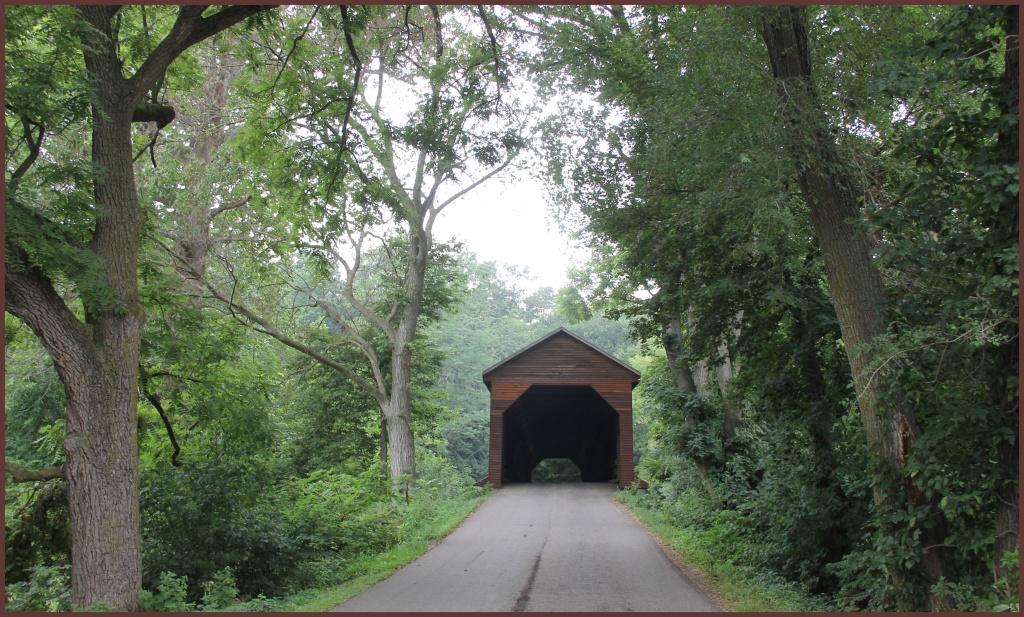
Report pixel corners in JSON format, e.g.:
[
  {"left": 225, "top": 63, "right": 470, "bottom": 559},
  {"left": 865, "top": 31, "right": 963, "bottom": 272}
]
[{"left": 74, "top": 104, "right": 145, "bottom": 610}]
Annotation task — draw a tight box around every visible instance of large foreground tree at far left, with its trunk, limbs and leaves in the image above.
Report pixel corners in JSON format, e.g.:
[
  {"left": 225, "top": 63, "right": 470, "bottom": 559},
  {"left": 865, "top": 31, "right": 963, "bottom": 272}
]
[{"left": 4, "top": 6, "right": 267, "bottom": 610}]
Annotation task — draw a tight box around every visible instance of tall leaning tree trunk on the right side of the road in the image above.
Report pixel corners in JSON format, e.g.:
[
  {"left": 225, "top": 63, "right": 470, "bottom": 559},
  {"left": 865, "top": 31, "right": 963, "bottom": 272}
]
[{"left": 761, "top": 6, "right": 955, "bottom": 609}]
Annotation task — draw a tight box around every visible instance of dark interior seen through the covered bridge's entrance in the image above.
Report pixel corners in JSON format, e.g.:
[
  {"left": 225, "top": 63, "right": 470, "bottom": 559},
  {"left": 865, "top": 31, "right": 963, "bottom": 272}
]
[{"left": 502, "top": 386, "right": 618, "bottom": 483}]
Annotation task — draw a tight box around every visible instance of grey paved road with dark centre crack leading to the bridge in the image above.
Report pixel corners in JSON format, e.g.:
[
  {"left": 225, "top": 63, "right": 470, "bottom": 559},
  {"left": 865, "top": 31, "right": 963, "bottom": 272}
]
[{"left": 334, "top": 484, "right": 721, "bottom": 612}]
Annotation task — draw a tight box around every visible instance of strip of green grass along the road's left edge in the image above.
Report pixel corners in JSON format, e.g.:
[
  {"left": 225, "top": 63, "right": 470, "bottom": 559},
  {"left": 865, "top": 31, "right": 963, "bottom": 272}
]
[{"left": 243, "top": 491, "right": 490, "bottom": 613}]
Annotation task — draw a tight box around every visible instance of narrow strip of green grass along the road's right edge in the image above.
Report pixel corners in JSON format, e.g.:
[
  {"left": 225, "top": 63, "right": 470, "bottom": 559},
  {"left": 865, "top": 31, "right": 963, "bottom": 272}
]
[{"left": 618, "top": 493, "right": 829, "bottom": 613}]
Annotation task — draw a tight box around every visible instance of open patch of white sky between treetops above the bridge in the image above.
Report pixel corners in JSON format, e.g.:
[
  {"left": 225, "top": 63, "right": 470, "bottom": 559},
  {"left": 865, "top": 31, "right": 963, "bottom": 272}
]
[{"left": 434, "top": 172, "right": 586, "bottom": 293}]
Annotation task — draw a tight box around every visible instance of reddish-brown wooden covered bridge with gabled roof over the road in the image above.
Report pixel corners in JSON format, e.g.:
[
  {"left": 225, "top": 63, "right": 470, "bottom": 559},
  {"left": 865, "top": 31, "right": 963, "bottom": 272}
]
[{"left": 483, "top": 327, "right": 640, "bottom": 488}]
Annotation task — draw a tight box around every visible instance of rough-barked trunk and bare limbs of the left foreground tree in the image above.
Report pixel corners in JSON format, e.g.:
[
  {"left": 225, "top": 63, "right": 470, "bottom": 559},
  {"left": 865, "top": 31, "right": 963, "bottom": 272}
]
[{"left": 4, "top": 6, "right": 267, "bottom": 611}]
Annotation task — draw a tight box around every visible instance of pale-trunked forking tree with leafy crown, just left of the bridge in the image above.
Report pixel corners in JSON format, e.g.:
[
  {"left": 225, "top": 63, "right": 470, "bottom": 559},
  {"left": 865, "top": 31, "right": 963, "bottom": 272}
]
[{"left": 158, "top": 6, "right": 523, "bottom": 485}]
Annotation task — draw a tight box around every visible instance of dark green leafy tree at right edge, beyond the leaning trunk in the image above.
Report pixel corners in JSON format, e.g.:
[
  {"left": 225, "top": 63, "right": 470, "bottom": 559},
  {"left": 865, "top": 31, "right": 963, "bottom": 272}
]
[{"left": 866, "top": 6, "right": 1020, "bottom": 593}]
